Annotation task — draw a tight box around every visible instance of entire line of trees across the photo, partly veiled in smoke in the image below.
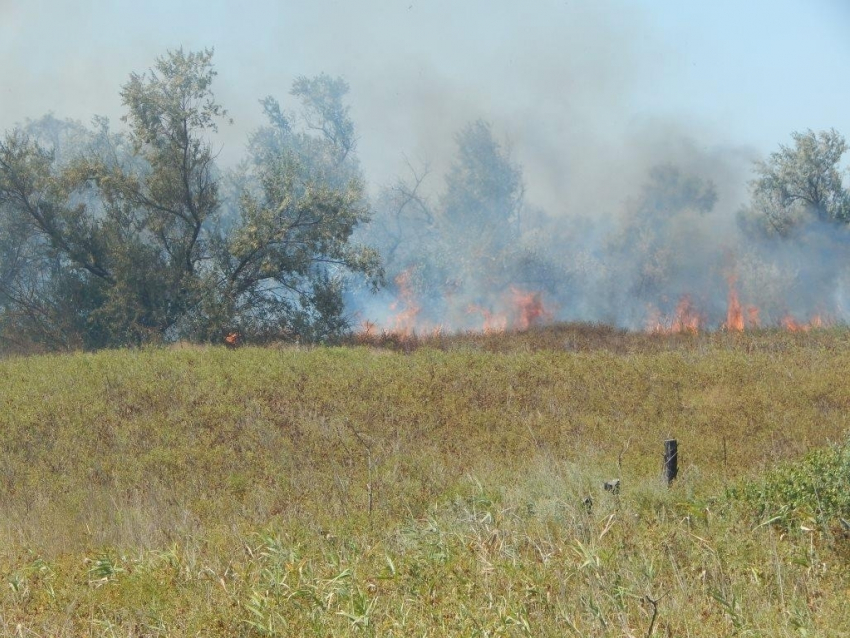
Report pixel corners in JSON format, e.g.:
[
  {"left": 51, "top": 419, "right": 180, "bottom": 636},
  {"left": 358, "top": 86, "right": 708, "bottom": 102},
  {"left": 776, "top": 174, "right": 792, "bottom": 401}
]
[{"left": 0, "top": 50, "right": 850, "bottom": 351}]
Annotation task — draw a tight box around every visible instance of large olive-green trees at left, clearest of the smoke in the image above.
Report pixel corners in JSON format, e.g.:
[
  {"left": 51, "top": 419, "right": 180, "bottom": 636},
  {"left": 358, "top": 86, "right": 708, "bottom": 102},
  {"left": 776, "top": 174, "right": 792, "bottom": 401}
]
[{"left": 0, "top": 49, "right": 380, "bottom": 347}]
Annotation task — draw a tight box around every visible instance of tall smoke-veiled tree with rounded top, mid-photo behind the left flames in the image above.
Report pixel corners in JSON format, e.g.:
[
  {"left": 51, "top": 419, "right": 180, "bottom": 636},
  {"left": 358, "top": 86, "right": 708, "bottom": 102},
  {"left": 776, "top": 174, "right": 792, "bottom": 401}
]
[{"left": 360, "top": 120, "right": 548, "bottom": 327}]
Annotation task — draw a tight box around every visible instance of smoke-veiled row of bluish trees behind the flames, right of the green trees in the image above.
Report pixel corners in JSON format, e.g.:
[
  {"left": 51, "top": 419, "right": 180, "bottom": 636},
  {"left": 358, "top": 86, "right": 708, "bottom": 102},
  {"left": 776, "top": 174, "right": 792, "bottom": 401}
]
[{"left": 369, "top": 127, "right": 850, "bottom": 329}]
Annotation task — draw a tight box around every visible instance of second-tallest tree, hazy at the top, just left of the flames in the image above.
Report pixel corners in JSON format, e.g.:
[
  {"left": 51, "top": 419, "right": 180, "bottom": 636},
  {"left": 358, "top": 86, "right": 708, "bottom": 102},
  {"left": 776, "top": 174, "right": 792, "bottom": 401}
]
[{"left": 223, "top": 75, "right": 383, "bottom": 340}]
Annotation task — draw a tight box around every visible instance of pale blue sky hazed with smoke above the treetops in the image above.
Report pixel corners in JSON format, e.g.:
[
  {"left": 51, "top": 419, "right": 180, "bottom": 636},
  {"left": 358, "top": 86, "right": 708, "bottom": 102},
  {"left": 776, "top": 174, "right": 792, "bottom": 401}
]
[{"left": 0, "top": 0, "right": 850, "bottom": 208}]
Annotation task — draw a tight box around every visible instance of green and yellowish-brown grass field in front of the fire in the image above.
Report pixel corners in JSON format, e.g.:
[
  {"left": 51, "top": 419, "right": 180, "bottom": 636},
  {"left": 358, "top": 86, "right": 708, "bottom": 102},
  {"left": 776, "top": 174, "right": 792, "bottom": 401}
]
[{"left": 0, "top": 326, "right": 850, "bottom": 637}]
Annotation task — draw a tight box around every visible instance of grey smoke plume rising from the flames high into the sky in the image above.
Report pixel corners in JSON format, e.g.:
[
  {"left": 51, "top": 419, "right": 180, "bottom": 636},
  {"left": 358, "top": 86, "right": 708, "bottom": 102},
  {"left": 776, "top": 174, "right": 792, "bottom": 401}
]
[{"left": 314, "top": 7, "right": 848, "bottom": 332}]
